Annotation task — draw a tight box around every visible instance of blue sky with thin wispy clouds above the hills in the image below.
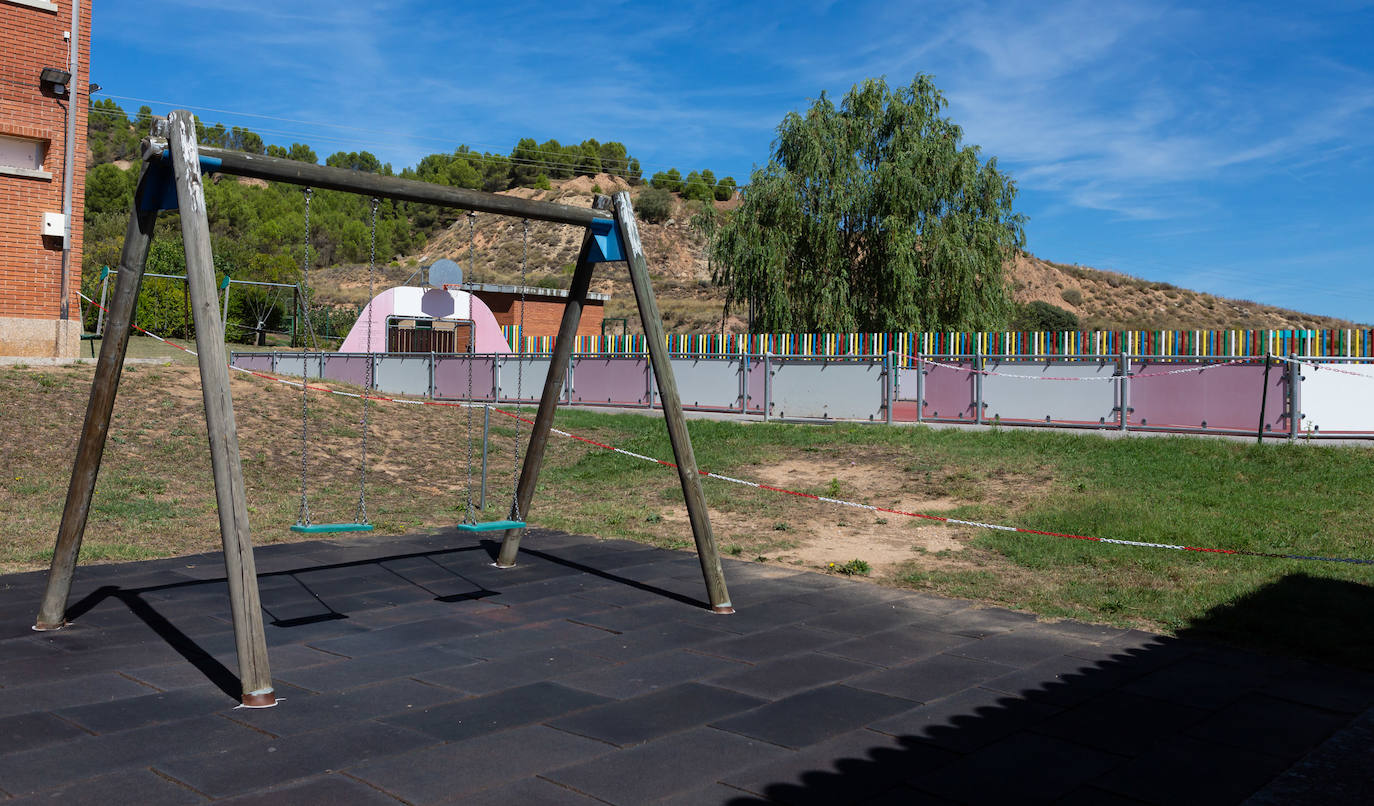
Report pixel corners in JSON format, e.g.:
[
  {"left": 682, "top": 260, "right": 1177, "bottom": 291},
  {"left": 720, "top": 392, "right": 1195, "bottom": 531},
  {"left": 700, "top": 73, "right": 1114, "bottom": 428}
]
[{"left": 91, "top": 0, "right": 1374, "bottom": 323}]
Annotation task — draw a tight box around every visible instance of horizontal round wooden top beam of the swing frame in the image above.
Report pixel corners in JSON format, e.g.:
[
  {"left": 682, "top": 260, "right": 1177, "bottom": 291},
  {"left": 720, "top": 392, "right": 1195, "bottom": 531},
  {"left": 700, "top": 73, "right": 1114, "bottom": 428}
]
[{"left": 143, "top": 124, "right": 613, "bottom": 227}]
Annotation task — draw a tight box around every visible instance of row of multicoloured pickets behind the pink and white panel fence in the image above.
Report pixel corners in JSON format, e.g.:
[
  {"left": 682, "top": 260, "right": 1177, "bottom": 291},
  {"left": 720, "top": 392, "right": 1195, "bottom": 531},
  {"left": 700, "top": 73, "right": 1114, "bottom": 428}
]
[{"left": 503, "top": 325, "right": 1374, "bottom": 362}]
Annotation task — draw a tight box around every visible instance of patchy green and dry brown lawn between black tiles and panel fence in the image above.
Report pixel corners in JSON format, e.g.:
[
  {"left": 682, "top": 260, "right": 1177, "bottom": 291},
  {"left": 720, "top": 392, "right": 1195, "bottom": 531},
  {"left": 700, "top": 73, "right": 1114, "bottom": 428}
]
[{"left": 0, "top": 365, "right": 1374, "bottom": 667}]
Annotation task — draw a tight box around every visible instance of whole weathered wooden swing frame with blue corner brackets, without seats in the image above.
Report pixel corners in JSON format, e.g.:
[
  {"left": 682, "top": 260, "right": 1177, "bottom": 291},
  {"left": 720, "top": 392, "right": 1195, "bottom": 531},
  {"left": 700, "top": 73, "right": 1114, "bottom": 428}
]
[{"left": 34, "top": 110, "right": 734, "bottom": 707}]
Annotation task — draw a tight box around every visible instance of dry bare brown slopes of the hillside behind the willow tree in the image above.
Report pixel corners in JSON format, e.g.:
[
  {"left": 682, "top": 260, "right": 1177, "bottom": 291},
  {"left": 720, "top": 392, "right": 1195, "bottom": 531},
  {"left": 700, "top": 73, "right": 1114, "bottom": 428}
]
[{"left": 317, "top": 174, "right": 1355, "bottom": 332}]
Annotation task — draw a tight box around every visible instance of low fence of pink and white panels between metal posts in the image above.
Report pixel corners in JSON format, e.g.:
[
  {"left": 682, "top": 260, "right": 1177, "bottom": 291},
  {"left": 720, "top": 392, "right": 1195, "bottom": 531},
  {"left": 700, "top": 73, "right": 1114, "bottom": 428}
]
[{"left": 231, "top": 352, "right": 1374, "bottom": 439}]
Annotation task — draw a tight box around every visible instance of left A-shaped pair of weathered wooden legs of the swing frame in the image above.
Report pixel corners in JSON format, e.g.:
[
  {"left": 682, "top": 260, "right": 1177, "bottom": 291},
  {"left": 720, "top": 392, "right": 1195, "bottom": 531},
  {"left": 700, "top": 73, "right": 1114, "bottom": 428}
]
[{"left": 34, "top": 111, "right": 276, "bottom": 707}]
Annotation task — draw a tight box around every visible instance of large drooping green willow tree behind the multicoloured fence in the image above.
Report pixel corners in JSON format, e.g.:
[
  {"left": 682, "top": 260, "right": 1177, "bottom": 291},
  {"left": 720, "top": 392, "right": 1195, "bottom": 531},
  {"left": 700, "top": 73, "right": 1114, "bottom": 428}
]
[{"left": 710, "top": 74, "right": 1025, "bottom": 332}]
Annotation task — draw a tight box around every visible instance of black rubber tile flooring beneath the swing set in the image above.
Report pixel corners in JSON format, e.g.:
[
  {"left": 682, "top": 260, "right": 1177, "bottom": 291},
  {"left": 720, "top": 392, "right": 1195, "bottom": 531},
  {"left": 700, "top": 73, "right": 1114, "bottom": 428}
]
[{"left": 0, "top": 530, "right": 1374, "bottom": 806}]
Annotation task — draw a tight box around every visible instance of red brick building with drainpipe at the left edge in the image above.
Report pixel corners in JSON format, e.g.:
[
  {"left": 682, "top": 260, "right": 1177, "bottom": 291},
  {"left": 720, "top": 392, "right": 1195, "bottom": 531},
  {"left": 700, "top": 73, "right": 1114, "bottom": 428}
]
[{"left": 0, "top": 0, "right": 91, "bottom": 358}]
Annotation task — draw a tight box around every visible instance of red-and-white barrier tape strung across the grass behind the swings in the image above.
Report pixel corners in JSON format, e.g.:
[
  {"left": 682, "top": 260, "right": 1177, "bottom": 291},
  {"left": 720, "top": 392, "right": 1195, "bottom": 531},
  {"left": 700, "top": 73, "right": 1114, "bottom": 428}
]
[{"left": 78, "top": 292, "right": 1374, "bottom": 566}]
